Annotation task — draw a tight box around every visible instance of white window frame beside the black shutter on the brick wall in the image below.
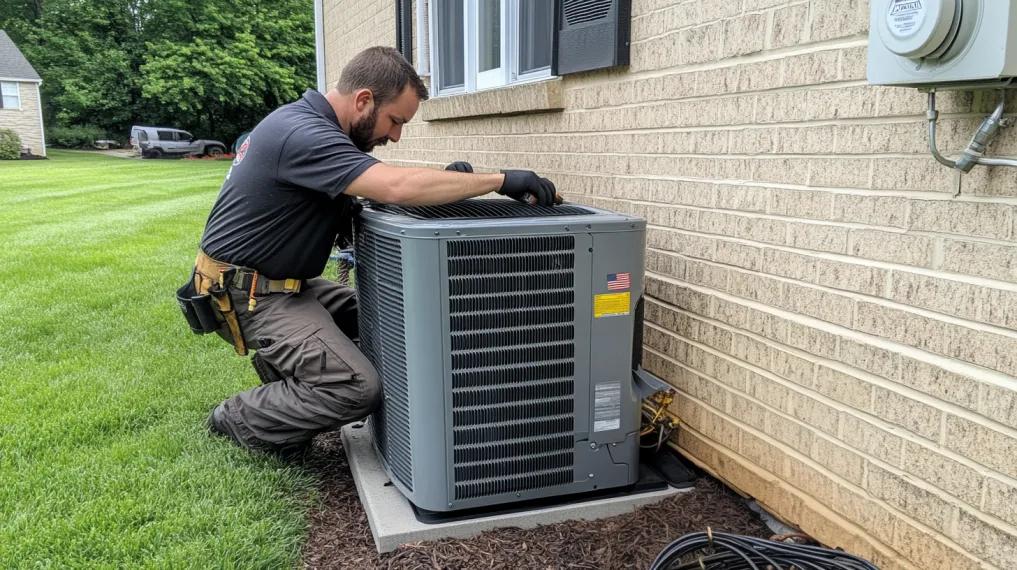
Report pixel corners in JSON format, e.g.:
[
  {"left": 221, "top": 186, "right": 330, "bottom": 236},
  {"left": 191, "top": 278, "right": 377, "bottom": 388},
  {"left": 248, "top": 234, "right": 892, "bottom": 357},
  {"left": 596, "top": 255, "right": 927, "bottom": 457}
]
[{"left": 428, "top": 0, "right": 552, "bottom": 97}]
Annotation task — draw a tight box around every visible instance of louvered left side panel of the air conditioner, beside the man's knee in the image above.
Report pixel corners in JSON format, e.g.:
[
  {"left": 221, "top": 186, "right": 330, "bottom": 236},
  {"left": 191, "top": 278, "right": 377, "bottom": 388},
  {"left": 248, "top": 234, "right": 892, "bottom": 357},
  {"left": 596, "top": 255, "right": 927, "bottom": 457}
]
[{"left": 356, "top": 228, "right": 413, "bottom": 491}]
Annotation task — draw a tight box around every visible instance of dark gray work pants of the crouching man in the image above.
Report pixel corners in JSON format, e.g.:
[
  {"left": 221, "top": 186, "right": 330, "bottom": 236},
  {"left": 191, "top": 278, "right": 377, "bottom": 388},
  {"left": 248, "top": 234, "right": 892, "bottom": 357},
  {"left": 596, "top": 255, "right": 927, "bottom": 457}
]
[{"left": 214, "top": 278, "right": 381, "bottom": 451}]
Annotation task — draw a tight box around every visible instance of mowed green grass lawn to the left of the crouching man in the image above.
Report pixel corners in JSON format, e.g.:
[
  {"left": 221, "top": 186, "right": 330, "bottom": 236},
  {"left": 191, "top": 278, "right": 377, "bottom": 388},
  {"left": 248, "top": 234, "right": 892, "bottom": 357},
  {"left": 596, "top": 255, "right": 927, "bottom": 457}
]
[{"left": 0, "top": 151, "right": 313, "bottom": 568}]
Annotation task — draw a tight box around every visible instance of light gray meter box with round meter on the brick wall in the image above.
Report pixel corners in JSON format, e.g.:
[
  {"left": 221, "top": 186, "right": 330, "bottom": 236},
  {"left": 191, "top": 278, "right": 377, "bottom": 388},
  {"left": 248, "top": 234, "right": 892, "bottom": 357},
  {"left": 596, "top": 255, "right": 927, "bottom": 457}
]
[{"left": 868, "top": 0, "right": 1017, "bottom": 89}]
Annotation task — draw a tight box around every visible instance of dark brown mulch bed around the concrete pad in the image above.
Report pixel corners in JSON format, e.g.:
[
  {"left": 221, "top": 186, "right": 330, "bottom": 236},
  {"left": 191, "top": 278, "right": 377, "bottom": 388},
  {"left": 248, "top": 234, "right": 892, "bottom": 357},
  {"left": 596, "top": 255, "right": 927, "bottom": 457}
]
[{"left": 302, "top": 433, "right": 772, "bottom": 570}]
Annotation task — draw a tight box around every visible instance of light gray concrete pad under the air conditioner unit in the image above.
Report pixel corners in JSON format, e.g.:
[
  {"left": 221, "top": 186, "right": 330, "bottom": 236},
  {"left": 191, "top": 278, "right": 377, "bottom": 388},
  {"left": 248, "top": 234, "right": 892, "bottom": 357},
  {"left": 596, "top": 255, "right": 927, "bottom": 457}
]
[{"left": 342, "top": 422, "right": 691, "bottom": 553}]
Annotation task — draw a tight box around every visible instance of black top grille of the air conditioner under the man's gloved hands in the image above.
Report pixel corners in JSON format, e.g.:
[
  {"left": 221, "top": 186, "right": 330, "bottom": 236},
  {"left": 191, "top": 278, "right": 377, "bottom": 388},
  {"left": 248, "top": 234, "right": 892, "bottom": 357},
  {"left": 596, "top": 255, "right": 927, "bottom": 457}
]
[{"left": 371, "top": 200, "right": 593, "bottom": 220}]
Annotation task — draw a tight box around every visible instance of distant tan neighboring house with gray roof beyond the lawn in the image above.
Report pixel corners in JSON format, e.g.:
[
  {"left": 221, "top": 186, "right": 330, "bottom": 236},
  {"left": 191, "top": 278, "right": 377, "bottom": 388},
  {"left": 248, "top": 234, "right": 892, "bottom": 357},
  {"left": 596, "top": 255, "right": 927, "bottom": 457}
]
[{"left": 0, "top": 30, "right": 46, "bottom": 157}]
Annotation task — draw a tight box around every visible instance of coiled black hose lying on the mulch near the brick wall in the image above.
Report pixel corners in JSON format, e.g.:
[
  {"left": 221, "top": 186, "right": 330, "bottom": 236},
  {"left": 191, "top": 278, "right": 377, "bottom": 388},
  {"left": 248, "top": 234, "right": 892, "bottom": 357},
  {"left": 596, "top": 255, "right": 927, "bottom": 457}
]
[{"left": 650, "top": 531, "right": 879, "bottom": 570}]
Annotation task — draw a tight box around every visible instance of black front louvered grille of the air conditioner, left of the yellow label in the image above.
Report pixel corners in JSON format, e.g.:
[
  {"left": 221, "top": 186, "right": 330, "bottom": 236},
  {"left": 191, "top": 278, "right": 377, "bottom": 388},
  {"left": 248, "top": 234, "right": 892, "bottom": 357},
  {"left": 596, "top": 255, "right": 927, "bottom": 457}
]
[{"left": 447, "top": 235, "right": 576, "bottom": 500}]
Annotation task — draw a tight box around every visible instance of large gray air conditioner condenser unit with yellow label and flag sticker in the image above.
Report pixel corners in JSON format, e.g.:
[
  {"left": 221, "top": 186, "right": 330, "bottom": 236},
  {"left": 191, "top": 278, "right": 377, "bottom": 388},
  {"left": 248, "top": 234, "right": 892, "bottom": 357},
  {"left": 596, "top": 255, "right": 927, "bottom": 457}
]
[{"left": 356, "top": 200, "right": 646, "bottom": 511}]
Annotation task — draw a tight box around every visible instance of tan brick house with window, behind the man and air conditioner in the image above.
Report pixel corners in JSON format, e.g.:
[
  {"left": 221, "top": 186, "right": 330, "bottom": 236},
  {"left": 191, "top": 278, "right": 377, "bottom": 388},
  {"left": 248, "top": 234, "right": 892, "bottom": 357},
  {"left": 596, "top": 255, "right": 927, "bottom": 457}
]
[{"left": 315, "top": 0, "right": 1017, "bottom": 569}]
